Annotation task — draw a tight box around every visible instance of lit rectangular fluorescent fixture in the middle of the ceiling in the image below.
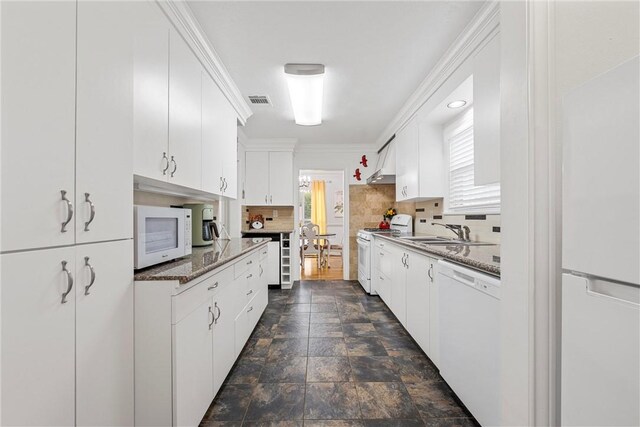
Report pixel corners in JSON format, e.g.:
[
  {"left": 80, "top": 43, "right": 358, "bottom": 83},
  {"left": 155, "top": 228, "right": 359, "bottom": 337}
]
[{"left": 284, "top": 64, "right": 324, "bottom": 126}]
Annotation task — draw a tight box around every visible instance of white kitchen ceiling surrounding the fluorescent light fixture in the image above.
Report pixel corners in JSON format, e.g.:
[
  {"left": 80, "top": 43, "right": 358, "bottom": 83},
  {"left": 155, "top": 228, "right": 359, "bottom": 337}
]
[{"left": 189, "top": 1, "right": 483, "bottom": 148}]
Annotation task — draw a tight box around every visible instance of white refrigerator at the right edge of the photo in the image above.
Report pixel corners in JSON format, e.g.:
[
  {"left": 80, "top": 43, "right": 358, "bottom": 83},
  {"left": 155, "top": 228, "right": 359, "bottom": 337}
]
[{"left": 561, "top": 57, "right": 640, "bottom": 426}]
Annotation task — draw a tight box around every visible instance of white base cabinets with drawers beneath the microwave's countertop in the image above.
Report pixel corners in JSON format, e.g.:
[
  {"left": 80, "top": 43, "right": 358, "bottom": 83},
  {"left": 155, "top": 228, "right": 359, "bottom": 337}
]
[{"left": 135, "top": 246, "right": 268, "bottom": 426}]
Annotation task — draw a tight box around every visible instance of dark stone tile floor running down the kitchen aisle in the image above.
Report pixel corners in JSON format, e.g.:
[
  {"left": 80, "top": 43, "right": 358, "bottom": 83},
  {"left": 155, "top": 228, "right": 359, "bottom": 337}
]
[{"left": 201, "top": 281, "right": 478, "bottom": 427}]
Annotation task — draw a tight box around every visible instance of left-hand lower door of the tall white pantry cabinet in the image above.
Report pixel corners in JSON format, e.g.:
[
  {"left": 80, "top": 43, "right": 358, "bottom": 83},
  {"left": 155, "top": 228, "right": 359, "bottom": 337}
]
[{"left": 1, "top": 247, "right": 76, "bottom": 426}]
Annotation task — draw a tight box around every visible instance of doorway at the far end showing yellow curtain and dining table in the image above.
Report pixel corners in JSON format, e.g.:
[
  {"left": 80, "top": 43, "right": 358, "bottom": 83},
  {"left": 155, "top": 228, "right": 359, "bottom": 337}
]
[{"left": 298, "top": 170, "right": 345, "bottom": 280}]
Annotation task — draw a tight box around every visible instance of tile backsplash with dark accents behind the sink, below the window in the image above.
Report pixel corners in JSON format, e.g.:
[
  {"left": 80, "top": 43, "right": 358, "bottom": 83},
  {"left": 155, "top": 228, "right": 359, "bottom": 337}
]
[{"left": 413, "top": 199, "right": 500, "bottom": 244}]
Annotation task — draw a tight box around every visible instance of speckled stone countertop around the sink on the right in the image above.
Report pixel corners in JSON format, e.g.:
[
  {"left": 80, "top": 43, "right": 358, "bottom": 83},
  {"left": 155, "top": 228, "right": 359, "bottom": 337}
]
[{"left": 375, "top": 234, "right": 500, "bottom": 277}]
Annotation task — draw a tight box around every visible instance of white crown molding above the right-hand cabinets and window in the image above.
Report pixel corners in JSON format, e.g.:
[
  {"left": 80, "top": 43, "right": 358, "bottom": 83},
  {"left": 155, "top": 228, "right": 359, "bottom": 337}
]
[{"left": 375, "top": 1, "right": 500, "bottom": 147}]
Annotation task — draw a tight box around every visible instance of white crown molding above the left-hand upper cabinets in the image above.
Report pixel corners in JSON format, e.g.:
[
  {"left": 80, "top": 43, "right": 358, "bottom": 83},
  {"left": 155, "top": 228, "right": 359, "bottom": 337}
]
[{"left": 155, "top": 0, "right": 253, "bottom": 126}]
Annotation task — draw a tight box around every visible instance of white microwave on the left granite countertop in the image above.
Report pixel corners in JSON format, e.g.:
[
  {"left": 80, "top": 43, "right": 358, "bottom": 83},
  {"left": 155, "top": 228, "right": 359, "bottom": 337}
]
[{"left": 133, "top": 205, "right": 191, "bottom": 269}]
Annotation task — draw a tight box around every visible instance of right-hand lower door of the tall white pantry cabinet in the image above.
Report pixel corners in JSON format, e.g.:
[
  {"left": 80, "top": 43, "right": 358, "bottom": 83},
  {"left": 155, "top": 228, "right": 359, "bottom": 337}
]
[{"left": 75, "top": 240, "right": 134, "bottom": 426}]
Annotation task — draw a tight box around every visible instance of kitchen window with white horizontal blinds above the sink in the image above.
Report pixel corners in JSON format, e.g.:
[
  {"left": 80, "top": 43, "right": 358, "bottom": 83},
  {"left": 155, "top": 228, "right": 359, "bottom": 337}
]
[{"left": 444, "top": 108, "right": 500, "bottom": 214}]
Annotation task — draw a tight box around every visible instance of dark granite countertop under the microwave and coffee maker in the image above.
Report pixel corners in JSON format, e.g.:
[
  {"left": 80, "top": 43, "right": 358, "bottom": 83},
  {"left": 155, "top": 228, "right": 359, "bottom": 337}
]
[{"left": 133, "top": 238, "right": 269, "bottom": 285}]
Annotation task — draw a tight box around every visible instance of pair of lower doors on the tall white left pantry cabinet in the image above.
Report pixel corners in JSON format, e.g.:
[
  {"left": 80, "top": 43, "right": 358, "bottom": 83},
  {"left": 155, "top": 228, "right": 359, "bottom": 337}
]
[{"left": 1, "top": 240, "right": 134, "bottom": 426}]
